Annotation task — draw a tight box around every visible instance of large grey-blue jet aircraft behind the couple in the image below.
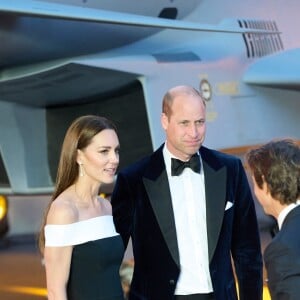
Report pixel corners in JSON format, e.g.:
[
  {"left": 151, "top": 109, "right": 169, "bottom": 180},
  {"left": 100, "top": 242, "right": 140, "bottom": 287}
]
[{"left": 0, "top": 0, "right": 300, "bottom": 194}]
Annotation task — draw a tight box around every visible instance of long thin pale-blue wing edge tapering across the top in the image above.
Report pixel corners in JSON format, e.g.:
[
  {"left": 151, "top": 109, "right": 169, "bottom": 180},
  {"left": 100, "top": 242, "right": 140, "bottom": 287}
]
[{"left": 0, "top": 0, "right": 278, "bottom": 34}]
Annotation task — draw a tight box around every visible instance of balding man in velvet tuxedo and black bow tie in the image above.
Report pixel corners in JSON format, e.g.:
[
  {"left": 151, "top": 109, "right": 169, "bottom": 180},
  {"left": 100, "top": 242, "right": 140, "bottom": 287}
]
[{"left": 112, "top": 86, "right": 262, "bottom": 300}]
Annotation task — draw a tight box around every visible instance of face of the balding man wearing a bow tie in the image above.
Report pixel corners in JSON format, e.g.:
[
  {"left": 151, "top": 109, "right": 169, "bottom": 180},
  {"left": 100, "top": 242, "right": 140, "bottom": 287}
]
[{"left": 161, "top": 95, "right": 206, "bottom": 161}]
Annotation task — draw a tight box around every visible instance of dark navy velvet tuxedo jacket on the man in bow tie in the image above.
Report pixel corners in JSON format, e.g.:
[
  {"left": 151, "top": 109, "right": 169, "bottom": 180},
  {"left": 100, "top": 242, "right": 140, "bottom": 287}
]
[{"left": 112, "top": 145, "right": 262, "bottom": 300}]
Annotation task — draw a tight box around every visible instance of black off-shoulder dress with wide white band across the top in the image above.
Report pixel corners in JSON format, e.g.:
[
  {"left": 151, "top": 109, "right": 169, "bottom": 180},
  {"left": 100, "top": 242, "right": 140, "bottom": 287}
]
[{"left": 45, "top": 216, "right": 124, "bottom": 300}]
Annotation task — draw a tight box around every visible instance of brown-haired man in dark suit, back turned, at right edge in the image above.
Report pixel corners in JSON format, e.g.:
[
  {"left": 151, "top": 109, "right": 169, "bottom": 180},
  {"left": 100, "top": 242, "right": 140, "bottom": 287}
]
[{"left": 247, "top": 139, "right": 300, "bottom": 300}]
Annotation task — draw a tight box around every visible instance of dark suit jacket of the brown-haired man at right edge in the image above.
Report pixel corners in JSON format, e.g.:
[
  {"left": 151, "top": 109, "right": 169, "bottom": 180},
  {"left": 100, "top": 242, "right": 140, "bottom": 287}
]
[{"left": 264, "top": 206, "right": 300, "bottom": 300}]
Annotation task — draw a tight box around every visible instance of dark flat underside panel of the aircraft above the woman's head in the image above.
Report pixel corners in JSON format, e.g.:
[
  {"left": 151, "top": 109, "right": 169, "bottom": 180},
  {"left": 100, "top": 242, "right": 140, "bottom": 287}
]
[{"left": 0, "top": 57, "right": 143, "bottom": 107}]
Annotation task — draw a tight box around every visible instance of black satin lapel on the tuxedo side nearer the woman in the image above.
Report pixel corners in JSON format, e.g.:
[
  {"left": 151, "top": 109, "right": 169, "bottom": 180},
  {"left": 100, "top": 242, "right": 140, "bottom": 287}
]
[{"left": 143, "top": 170, "right": 179, "bottom": 266}]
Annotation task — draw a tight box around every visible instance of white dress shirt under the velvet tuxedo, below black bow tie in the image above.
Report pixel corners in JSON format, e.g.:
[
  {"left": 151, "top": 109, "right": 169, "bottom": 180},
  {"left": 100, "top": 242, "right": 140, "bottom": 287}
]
[{"left": 163, "top": 145, "right": 213, "bottom": 295}]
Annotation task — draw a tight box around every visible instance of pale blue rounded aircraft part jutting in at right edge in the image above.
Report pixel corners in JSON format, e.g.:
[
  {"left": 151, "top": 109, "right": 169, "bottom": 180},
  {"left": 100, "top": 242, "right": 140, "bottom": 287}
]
[{"left": 243, "top": 48, "right": 300, "bottom": 90}]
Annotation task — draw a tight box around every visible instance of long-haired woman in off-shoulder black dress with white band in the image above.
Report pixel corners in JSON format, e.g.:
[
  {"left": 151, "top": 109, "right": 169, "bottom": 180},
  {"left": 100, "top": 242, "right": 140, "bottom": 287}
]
[{"left": 39, "top": 115, "right": 124, "bottom": 300}]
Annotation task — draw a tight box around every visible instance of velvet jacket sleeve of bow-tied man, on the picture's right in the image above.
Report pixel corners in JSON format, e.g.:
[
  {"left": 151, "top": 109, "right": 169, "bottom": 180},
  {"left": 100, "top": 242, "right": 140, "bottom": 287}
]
[{"left": 230, "top": 159, "right": 263, "bottom": 300}]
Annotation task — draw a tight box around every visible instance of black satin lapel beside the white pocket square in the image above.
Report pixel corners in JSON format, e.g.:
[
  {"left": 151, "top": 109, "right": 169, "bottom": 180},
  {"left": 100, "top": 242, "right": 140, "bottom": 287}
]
[{"left": 203, "top": 161, "right": 227, "bottom": 261}]
